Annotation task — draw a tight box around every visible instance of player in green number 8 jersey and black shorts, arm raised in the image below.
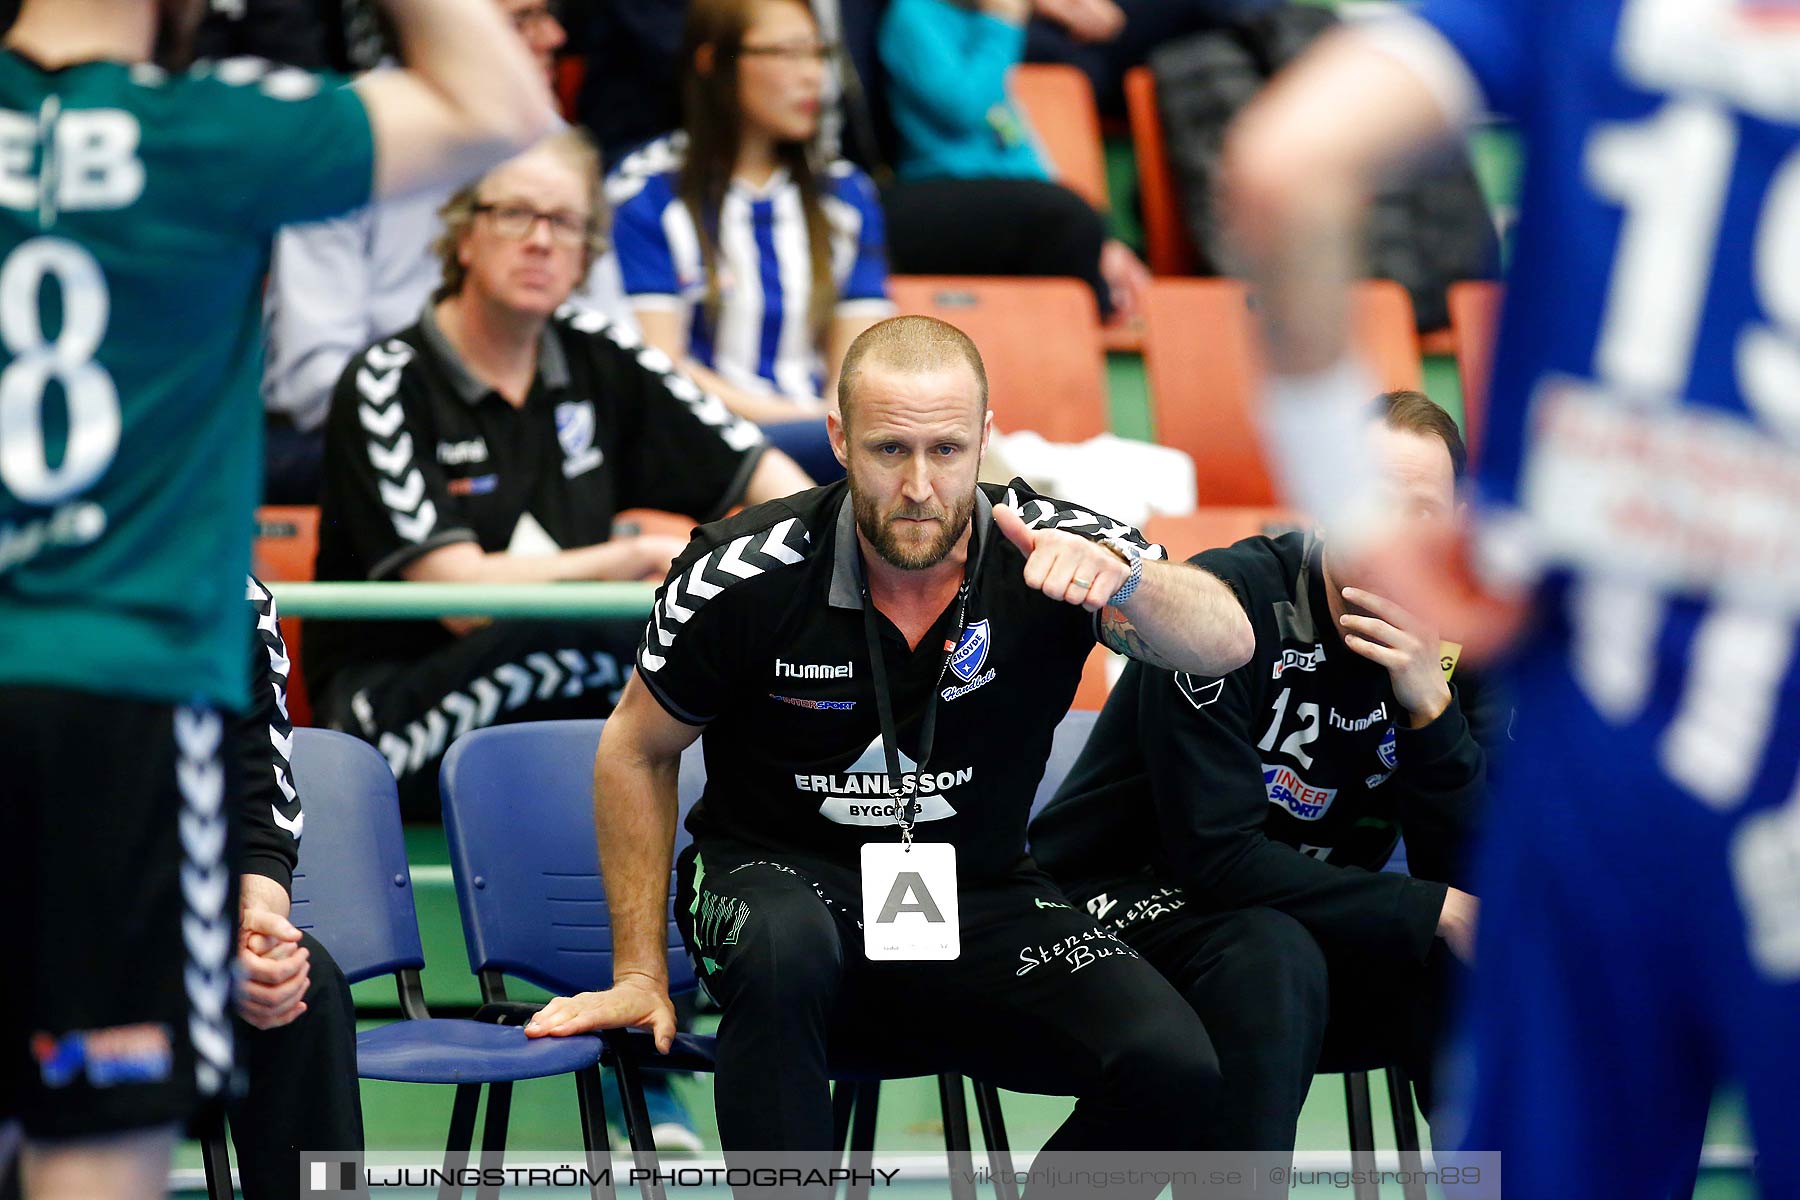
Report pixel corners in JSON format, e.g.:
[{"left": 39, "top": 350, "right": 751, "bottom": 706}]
[{"left": 0, "top": 0, "right": 551, "bottom": 1196}]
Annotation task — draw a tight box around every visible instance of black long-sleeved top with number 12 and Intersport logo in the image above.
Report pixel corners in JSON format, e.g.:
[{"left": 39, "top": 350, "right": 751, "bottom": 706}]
[{"left": 1031, "top": 533, "right": 1492, "bottom": 959}]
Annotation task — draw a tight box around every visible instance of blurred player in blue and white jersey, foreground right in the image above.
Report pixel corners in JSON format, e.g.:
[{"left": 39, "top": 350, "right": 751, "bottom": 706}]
[{"left": 1228, "top": 0, "right": 1800, "bottom": 1200}]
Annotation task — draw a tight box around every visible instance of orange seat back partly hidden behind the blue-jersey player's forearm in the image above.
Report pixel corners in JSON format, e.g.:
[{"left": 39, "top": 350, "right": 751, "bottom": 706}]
[{"left": 1145, "top": 279, "right": 1424, "bottom": 507}]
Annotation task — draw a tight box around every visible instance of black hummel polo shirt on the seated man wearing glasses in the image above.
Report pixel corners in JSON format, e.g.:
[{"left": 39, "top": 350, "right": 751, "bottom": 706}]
[{"left": 306, "top": 308, "right": 763, "bottom": 689}]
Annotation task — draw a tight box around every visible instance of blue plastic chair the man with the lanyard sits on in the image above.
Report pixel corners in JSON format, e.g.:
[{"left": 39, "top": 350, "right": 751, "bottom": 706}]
[{"left": 439, "top": 720, "right": 1044, "bottom": 1196}]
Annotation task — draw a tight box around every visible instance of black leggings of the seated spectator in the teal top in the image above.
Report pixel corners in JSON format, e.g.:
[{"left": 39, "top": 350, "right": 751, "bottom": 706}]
[{"left": 882, "top": 180, "right": 1112, "bottom": 317}]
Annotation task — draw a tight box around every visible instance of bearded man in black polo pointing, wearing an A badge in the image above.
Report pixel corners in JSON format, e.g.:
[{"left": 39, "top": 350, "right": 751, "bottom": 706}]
[{"left": 526, "top": 317, "right": 1251, "bottom": 1180}]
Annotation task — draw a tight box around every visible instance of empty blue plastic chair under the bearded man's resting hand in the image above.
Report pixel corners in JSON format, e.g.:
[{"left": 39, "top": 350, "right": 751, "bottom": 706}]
[{"left": 209, "top": 729, "right": 612, "bottom": 1196}]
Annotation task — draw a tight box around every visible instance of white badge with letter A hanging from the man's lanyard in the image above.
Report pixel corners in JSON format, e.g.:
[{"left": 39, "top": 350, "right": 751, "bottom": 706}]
[{"left": 862, "top": 842, "right": 961, "bottom": 961}]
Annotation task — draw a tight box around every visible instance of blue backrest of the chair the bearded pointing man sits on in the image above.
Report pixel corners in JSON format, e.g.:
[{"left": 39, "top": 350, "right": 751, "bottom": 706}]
[{"left": 441, "top": 721, "right": 693, "bottom": 995}]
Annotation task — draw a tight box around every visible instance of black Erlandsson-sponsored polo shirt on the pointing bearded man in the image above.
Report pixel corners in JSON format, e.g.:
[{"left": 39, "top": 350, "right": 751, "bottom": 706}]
[{"left": 637, "top": 480, "right": 1161, "bottom": 882}]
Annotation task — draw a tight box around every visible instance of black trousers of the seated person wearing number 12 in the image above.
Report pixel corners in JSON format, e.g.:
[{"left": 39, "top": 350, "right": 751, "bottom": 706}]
[{"left": 1071, "top": 876, "right": 1453, "bottom": 1151}]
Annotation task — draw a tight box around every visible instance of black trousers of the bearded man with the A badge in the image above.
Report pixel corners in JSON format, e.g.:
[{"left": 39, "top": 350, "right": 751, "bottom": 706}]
[{"left": 677, "top": 840, "right": 1219, "bottom": 1195}]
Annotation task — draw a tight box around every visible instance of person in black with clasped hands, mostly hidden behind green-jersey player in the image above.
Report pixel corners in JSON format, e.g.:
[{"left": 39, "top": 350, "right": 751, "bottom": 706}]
[{"left": 229, "top": 578, "right": 362, "bottom": 1200}]
